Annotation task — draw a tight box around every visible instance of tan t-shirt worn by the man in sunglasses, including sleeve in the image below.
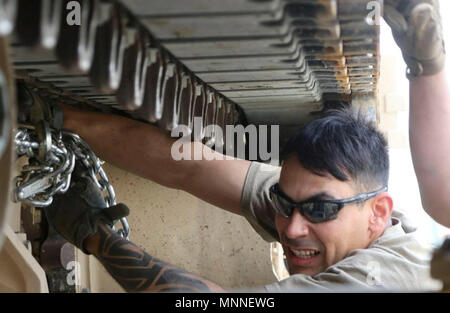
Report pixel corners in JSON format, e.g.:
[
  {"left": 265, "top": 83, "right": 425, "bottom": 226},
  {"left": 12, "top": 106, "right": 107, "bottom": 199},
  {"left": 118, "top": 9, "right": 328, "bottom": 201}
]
[{"left": 241, "top": 162, "right": 441, "bottom": 292}]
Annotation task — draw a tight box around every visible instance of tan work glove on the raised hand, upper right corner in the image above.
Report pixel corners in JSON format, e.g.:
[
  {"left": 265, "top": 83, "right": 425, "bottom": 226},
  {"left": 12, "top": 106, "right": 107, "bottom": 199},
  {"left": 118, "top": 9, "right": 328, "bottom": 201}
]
[{"left": 384, "top": 0, "right": 445, "bottom": 79}]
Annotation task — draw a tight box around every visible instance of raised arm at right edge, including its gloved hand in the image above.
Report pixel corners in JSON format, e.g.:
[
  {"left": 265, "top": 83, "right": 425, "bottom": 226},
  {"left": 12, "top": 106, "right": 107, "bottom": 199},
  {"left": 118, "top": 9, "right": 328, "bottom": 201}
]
[{"left": 384, "top": 0, "right": 450, "bottom": 227}]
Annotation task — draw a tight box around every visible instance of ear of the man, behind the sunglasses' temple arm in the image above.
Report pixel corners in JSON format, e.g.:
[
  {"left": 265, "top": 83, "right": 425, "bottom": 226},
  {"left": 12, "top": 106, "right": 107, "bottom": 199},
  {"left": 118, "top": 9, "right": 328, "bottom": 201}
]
[{"left": 369, "top": 192, "right": 394, "bottom": 236}]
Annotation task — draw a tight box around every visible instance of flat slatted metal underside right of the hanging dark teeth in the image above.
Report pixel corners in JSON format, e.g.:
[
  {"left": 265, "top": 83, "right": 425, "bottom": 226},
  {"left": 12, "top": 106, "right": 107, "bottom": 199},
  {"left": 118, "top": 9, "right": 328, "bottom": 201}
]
[{"left": 123, "top": 0, "right": 379, "bottom": 122}]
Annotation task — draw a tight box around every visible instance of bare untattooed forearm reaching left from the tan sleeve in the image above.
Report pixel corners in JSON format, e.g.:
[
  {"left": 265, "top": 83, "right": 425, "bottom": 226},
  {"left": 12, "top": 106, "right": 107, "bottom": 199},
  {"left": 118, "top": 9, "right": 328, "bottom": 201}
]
[{"left": 61, "top": 104, "right": 250, "bottom": 214}]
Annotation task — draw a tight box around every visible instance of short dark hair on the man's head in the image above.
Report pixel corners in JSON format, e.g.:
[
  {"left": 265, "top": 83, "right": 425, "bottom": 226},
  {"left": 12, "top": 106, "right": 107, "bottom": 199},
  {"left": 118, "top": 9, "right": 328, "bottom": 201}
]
[{"left": 282, "top": 109, "right": 389, "bottom": 191}]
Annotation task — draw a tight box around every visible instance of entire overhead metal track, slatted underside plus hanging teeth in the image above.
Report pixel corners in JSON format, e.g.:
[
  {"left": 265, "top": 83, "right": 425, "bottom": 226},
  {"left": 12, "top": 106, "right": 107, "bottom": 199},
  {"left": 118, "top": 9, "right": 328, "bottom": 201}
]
[{"left": 7, "top": 0, "right": 379, "bottom": 140}]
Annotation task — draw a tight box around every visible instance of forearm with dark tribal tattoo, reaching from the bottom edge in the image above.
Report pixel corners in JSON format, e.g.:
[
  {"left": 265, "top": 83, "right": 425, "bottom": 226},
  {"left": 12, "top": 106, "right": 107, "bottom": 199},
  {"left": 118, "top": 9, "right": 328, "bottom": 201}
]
[{"left": 95, "top": 224, "right": 211, "bottom": 292}]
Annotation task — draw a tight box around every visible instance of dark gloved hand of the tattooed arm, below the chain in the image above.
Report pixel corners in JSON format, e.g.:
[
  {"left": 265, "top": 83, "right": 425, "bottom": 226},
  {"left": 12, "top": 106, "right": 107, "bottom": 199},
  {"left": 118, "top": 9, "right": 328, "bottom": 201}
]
[{"left": 45, "top": 164, "right": 129, "bottom": 254}]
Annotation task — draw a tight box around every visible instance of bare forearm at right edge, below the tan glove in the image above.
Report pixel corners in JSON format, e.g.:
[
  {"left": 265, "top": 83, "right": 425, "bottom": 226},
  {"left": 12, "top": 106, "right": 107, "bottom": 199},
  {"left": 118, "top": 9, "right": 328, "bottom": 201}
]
[{"left": 410, "top": 71, "right": 450, "bottom": 227}]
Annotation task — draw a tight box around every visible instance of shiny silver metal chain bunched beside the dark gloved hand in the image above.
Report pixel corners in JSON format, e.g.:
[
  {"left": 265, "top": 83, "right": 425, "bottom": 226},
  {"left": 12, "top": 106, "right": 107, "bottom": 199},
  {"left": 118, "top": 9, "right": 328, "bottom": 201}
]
[{"left": 14, "top": 125, "right": 130, "bottom": 238}]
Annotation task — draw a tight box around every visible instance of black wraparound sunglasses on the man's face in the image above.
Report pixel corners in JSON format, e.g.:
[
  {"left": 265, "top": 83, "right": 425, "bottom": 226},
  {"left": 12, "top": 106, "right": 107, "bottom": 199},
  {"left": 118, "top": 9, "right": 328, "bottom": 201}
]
[{"left": 270, "top": 183, "right": 387, "bottom": 223}]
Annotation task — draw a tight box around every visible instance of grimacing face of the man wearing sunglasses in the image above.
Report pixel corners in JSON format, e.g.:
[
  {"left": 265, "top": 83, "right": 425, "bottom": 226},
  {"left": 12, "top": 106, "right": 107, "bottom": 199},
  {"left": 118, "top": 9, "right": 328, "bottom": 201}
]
[{"left": 275, "top": 157, "right": 371, "bottom": 276}]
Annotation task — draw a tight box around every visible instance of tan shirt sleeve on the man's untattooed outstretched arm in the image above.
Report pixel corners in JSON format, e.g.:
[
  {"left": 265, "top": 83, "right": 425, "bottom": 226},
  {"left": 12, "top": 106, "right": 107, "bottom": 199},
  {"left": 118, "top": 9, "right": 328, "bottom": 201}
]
[{"left": 241, "top": 162, "right": 281, "bottom": 242}]
